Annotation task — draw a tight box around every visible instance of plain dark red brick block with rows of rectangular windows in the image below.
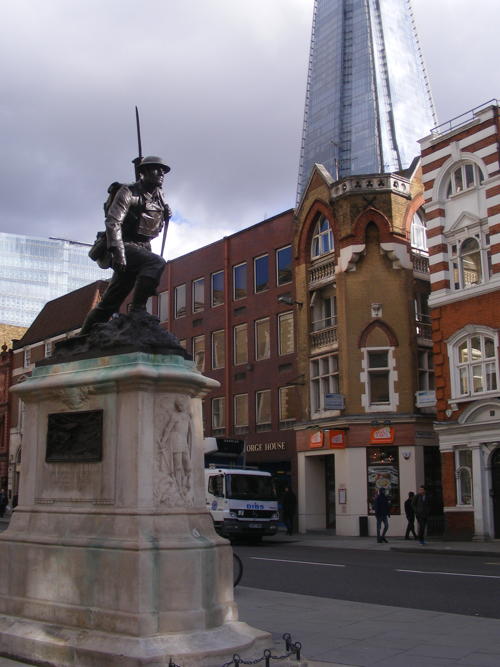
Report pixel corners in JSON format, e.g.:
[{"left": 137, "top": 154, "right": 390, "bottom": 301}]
[{"left": 133, "top": 210, "right": 303, "bottom": 494}]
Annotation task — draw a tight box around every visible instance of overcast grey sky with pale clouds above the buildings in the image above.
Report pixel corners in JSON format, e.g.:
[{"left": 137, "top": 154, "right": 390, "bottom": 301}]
[{"left": 0, "top": 0, "right": 500, "bottom": 258}]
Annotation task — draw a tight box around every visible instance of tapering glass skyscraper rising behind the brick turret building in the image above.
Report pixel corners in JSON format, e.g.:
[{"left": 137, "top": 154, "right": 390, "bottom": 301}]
[{"left": 297, "top": 0, "right": 437, "bottom": 200}]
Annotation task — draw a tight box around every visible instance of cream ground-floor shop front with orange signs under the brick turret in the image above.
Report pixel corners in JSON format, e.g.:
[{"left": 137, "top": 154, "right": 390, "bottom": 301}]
[{"left": 297, "top": 423, "right": 439, "bottom": 536}]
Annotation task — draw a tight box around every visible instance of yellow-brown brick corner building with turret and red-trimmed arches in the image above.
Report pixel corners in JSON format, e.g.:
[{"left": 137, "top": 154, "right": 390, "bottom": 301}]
[{"left": 294, "top": 160, "right": 441, "bottom": 535}]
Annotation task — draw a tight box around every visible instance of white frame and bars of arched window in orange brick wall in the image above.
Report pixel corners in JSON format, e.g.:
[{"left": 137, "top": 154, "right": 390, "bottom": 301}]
[{"left": 447, "top": 324, "right": 500, "bottom": 401}]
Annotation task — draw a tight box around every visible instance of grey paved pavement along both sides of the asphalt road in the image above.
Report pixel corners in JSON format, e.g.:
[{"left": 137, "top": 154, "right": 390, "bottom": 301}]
[{"left": 0, "top": 520, "right": 500, "bottom": 667}]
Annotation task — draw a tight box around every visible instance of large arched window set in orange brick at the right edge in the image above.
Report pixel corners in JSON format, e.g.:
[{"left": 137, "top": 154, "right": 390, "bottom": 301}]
[{"left": 452, "top": 332, "right": 498, "bottom": 398}]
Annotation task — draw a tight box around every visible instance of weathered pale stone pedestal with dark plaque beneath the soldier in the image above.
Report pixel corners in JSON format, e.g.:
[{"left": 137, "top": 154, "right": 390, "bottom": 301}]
[{"left": 0, "top": 352, "right": 270, "bottom": 667}]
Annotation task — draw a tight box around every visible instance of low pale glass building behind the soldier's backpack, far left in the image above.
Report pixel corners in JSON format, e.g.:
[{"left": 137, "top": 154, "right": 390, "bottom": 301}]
[{"left": 0, "top": 233, "right": 112, "bottom": 327}]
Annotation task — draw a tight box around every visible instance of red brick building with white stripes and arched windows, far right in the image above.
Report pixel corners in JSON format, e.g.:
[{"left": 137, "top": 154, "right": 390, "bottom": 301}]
[{"left": 421, "top": 100, "right": 500, "bottom": 539}]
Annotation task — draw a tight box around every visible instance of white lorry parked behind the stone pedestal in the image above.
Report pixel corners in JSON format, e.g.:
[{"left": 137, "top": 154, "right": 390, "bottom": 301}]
[{"left": 205, "top": 466, "right": 279, "bottom": 540}]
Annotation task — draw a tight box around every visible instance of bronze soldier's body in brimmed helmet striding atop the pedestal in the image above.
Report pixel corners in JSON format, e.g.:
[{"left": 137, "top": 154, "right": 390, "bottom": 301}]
[{"left": 80, "top": 156, "right": 170, "bottom": 335}]
